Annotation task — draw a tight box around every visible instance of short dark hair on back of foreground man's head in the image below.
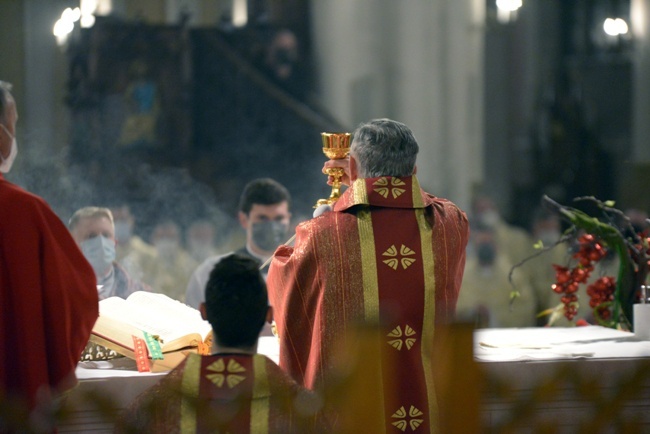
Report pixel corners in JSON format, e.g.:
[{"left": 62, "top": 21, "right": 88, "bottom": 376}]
[{"left": 205, "top": 254, "right": 268, "bottom": 347}]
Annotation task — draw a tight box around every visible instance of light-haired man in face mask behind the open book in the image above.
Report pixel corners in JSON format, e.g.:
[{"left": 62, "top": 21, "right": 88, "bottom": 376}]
[{"left": 68, "top": 206, "right": 149, "bottom": 300}]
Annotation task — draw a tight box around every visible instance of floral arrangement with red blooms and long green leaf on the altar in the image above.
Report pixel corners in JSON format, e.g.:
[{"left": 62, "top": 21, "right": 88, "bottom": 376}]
[{"left": 512, "top": 196, "right": 650, "bottom": 330}]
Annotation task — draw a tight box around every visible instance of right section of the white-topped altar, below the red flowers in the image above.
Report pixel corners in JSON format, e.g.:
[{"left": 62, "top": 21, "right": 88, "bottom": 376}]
[{"left": 474, "top": 326, "right": 650, "bottom": 433}]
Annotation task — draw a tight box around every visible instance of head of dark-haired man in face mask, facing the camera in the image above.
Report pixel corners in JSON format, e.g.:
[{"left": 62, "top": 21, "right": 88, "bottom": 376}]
[{"left": 239, "top": 178, "right": 291, "bottom": 257}]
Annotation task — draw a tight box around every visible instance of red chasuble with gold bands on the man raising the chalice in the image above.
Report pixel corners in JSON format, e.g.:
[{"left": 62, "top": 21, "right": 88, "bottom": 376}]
[{"left": 267, "top": 177, "right": 469, "bottom": 431}]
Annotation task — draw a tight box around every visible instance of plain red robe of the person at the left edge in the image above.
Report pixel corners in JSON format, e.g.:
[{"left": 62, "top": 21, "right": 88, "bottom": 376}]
[{"left": 0, "top": 175, "right": 99, "bottom": 406}]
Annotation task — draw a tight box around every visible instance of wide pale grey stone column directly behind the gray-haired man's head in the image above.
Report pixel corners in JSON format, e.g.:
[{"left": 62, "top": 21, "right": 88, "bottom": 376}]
[{"left": 312, "top": 0, "right": 485, "bottom": 208}]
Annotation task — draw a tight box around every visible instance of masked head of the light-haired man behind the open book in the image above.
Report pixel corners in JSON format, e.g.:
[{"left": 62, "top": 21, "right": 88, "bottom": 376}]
[{"left": 68, "top": 206, "right": 115, "bottom": 279}]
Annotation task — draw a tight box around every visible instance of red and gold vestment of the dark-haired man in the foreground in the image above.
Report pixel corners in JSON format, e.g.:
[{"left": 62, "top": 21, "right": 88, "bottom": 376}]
[{"left": 118, "top": 354, "right": 327, "bottom": 434}]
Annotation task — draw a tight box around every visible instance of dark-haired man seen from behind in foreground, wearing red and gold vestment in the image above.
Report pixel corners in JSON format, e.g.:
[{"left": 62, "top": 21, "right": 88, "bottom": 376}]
[{"left": 118, "top": 254, "right": 328, "bottom": 434}]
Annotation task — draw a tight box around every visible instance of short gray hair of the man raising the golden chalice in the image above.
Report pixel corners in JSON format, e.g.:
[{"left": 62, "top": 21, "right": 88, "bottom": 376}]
[{"left": 350, "top": 119, "right": 419, "bottom": 178}]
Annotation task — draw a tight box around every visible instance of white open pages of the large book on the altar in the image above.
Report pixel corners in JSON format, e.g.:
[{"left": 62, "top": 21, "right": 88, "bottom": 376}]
[{"left": 99, "top": 291, "right": 212, "bottom": 345}]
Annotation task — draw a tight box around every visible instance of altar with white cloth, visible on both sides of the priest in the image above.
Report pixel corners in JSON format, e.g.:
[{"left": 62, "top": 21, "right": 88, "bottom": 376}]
[{"left": 59, "top": 326, "right": 650, "bottom": 433}]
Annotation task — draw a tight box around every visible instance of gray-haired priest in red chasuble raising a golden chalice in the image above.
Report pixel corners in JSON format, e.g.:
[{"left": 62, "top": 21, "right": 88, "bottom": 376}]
[{"left": 267, "top": 119, "right": 469, "bottom": 432}]
